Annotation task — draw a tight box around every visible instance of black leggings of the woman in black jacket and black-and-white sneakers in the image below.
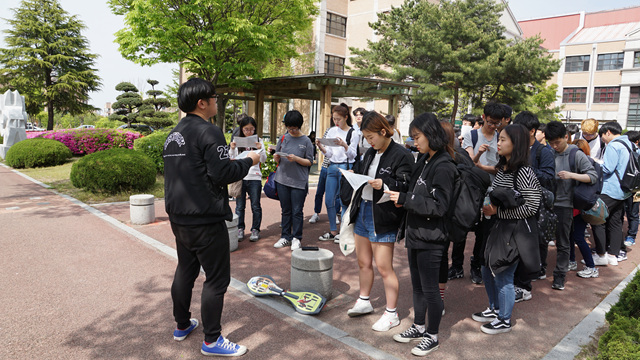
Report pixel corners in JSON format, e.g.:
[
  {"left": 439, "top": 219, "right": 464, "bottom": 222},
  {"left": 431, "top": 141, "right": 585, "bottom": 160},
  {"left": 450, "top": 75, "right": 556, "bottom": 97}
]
[{"left": 407, "top": 243, "right": 445, "bottom": 335}]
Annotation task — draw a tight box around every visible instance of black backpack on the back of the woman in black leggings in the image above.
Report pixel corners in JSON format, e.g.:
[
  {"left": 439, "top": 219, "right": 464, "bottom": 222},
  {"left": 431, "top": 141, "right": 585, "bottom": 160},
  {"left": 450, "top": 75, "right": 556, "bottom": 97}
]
[{"left": 451, "top": 151, "right": 491, "bottom": 232}]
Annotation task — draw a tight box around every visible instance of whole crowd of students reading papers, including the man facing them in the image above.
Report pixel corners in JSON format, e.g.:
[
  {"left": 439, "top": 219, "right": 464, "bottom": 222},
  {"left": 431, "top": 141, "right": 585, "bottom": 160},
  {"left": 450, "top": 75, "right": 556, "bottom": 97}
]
[{"left": 164, "top": 79, "right": 640, "bottom": 356}]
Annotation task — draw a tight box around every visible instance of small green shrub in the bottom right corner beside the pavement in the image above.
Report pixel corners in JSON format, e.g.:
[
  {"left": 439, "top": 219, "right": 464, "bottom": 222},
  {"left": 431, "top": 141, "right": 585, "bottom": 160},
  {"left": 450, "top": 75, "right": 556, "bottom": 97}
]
[{"left": 598, "top": 314, "right": 640, "bottom": 360}]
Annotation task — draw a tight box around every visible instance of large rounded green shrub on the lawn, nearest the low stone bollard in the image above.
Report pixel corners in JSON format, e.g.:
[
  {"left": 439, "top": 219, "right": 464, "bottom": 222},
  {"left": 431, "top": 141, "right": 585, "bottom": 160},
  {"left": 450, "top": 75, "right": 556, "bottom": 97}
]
[{"left": 70, "top": 148, "right": 156, "bottom": 194}]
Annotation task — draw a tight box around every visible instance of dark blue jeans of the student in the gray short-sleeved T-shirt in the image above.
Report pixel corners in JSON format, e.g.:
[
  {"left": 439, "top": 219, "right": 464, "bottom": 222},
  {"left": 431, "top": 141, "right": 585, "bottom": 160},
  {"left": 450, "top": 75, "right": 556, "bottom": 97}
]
[{"left": 276, "top": 182, "right": 307, "bottom": 241}]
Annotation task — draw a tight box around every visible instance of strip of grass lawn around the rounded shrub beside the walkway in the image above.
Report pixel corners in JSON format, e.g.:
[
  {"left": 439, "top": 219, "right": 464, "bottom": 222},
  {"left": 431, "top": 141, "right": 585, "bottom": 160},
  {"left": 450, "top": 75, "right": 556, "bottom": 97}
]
[{"left": 19, "top": 157, "right": 164, "bottom": 204}]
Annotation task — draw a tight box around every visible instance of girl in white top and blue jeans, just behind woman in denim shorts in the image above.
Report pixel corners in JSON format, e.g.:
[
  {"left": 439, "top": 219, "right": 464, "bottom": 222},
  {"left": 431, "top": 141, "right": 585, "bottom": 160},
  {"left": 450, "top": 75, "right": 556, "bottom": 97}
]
[{"left": 316, "top": 104, "right": 360, "bottom": 241}]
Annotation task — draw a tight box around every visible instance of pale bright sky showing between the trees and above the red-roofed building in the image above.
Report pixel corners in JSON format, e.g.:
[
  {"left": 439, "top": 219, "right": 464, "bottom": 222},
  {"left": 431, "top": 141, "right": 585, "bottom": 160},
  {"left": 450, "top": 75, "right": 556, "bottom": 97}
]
[{"left": 0, "top": 0, "right": 639, "bottom": 113}]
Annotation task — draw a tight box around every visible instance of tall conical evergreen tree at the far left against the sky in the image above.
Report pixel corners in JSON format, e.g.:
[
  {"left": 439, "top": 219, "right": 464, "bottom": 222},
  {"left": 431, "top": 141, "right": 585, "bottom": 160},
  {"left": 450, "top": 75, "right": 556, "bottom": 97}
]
[{"left": 0, "top": 0, "right": 100, "bottom": 130}]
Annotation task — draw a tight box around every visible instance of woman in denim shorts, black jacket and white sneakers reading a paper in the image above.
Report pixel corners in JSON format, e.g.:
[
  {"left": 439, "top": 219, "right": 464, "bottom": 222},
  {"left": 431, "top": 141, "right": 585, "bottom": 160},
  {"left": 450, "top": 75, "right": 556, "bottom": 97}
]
[{"left": 347, "top": 111, "right": 413, "bottom": 331}]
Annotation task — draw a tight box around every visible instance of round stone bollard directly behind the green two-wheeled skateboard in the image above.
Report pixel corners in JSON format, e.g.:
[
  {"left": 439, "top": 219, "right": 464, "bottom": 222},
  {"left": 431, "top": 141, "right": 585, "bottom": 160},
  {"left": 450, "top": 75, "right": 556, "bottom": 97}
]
[{"left": 290, "top": 249, "right": 333, "bottom": 300}]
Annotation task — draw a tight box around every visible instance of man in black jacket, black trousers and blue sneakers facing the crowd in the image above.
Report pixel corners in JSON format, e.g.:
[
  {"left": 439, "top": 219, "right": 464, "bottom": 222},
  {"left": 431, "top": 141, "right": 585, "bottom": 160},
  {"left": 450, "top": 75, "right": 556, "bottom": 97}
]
[{"left": 163, "top": 79, "right": 260, "bottom": 356}]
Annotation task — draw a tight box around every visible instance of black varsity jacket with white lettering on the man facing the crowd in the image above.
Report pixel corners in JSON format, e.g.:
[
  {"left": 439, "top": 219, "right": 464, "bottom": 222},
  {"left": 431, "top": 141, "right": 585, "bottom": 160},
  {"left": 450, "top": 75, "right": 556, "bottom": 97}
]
[{"left": 162, "top": 115, "right": 253, "bottom": 225}]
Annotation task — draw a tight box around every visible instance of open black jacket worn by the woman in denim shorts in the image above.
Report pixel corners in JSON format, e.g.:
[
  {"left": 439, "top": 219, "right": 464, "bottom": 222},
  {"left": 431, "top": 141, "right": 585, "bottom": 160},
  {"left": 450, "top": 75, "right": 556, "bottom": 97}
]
[{"left": 349, "top": 140, "right": 414, "bottom": 234}]
